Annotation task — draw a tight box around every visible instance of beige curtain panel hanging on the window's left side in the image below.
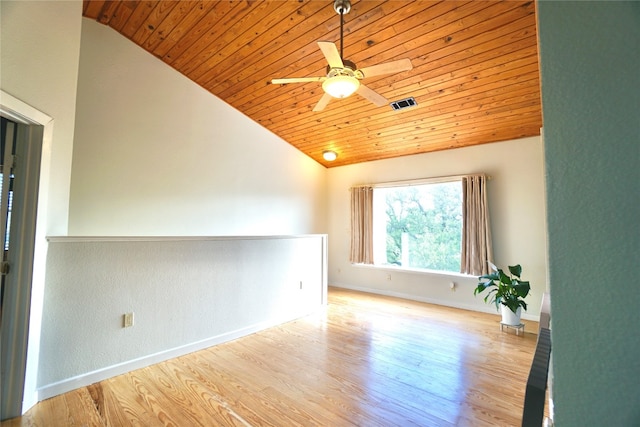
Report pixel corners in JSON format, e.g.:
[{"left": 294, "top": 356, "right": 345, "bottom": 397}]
[{"left": 349, "top": 187, "right": 373, "bottom": 264}]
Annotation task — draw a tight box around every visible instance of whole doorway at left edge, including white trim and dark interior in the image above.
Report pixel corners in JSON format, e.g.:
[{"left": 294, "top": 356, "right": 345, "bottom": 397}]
[{"left": 0, "top": 92, "right": 48, "bottom": 420}]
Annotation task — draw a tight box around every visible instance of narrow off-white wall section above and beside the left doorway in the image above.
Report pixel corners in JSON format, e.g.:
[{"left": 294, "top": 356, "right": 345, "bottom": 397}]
[{"left": 0, "top": 0, "right": 82, "bottom": 234}]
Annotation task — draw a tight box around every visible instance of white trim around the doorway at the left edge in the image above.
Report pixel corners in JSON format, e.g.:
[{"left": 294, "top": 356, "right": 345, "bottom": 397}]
[{"left": 0, "top": 89, "right": 54, "bottom": 414}]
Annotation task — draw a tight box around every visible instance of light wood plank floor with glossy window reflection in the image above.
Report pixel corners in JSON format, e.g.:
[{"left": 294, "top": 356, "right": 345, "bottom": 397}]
[{"left": 1, "top": 288, "right": 537, "bottom": 427}]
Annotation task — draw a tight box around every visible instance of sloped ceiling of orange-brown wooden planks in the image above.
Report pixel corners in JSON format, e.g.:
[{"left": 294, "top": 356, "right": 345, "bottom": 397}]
[{"left": 83, "top": 0, "right": 542, "bottom": 167}]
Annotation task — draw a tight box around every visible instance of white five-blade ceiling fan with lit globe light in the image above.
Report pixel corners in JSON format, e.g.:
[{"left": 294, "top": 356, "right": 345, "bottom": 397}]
[{"left": 271, "top": 0, "right": 413, "bottom": 111}]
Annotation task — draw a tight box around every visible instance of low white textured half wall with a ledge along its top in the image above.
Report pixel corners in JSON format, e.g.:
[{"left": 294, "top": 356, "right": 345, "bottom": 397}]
[{"left": 38, "top": 235, "right": 327, "bottom": 399}]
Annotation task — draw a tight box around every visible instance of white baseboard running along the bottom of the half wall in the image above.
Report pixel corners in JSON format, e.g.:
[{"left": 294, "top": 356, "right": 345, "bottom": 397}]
[{"left": 35, "top": 305, "right": 325, "bottom": 402}]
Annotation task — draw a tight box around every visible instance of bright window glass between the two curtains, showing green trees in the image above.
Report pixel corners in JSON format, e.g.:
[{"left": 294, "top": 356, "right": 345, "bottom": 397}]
[{"left": 373, "top": 179, "right": 463, "bottom": 272}]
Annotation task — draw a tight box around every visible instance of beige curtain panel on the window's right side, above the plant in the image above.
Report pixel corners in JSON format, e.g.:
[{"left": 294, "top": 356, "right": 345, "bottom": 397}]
[{"left": 460, "top": 175, "right": 493, "bottom": 276}]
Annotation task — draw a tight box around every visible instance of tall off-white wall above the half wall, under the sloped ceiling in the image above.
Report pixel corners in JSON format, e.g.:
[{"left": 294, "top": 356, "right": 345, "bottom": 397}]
[{"left": 69, "top": 18, "right": 326, "bottom": 235}]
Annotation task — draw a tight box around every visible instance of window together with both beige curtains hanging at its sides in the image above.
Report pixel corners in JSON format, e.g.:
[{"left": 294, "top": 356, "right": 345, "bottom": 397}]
[{"left": 349, "top": 174, "right": 493, "bottom": 276}]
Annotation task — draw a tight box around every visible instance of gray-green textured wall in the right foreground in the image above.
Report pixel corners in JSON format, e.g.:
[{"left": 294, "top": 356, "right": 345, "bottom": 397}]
[{"left": 538, "top": 1, "right": 640, "bottom": 427}]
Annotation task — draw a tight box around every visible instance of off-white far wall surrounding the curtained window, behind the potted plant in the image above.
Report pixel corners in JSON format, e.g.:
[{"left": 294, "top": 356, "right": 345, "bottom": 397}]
[{"left": 328, "top": 137, "right": 547, "bottom": 319}]
